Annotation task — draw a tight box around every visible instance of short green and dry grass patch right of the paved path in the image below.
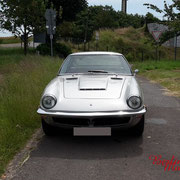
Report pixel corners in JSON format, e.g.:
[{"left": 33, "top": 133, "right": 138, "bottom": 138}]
[{"left": 133, "top": 60, "right": 180, "bottom": 97}]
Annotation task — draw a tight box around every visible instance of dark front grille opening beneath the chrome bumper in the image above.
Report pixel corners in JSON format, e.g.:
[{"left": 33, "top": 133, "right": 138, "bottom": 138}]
[{"left": 53, "top": 117, "right": 130, "bottom": 127}]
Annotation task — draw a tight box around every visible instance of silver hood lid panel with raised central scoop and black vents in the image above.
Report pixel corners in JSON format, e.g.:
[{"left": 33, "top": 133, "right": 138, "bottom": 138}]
[{"left": 63, "top": 75, "right": 126, "bottom": 99}]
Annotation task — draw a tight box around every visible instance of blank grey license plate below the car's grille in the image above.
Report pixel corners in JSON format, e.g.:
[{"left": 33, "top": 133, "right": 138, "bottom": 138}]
[{"left": 73, "top": 127, "right": 111, "bottom": 136}]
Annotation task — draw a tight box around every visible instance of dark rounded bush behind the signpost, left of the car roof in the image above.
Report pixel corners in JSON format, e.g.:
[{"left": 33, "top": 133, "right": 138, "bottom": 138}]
[{"left": 36, "top": 43, "right": 72, "bottom": 57}]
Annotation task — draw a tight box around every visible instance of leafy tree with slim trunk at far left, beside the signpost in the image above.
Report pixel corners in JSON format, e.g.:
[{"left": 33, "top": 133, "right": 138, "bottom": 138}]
[{"left": 0, "top": 0, "right": 45, "bottom": 55}]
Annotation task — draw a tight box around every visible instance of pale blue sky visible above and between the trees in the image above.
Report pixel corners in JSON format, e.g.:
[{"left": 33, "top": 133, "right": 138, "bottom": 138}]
[{"left": 0, "top": 0, "right": 172, "bottom": 37}]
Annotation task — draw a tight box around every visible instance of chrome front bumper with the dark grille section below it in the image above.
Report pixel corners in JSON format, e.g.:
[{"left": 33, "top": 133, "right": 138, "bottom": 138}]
[{"left": 37, "top": 107, "right": 146, "bottom": 127}]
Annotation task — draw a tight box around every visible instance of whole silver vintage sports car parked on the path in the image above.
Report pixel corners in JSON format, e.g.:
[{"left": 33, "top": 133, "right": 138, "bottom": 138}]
[{"left": 37, "top": 52, "right": 146, "bottom": 136}]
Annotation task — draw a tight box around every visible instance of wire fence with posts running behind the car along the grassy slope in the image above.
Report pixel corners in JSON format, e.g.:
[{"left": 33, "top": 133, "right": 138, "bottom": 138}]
[{"left": 60, "top": 38, "right": 180, "bottom": 61}]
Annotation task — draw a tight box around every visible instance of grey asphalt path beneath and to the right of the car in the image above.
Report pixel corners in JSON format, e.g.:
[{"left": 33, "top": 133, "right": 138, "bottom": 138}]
[{"left": 13, "top": 79, "right": 180, "bottom": 180}]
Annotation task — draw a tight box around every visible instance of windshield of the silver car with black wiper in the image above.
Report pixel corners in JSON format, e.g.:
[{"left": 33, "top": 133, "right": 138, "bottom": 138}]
[{"left": 60, "top": 55, "right": 132, "bottom": 75}]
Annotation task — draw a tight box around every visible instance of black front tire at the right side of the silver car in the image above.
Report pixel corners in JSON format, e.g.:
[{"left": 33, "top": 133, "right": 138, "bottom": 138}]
[{"left": 131, "top": 116, "right": 145, "bottom": 137}]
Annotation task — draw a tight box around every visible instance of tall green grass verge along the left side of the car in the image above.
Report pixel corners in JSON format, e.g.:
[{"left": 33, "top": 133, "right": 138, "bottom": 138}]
[{"left": 0, "top": 53, "right": 62, "bottom": 174}]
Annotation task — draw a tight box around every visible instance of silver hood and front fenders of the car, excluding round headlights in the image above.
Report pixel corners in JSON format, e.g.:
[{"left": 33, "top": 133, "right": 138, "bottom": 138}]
[{"left": 41, "top": 74, "right": 143, "bottom": 112}]
